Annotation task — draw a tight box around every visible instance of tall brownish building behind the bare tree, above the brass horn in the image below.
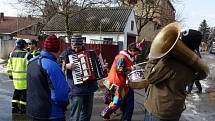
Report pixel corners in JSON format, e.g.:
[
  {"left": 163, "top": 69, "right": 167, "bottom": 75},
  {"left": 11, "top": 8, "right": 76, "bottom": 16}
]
[{"left": 121, "top": 0, "right": 175, "bottom": 41}]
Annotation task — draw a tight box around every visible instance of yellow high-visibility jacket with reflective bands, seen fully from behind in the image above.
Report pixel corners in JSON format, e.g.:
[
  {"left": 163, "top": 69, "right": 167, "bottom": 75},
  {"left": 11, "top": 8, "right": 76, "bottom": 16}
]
[{"left": 7, "top": 50, "right": 30, "bottom": 90}]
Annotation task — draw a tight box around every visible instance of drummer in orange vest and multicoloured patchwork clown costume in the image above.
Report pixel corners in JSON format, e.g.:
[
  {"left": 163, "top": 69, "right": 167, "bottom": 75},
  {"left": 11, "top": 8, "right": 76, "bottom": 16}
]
[{"left": 101, "top": 43, "right": 140, "bottom": 121}]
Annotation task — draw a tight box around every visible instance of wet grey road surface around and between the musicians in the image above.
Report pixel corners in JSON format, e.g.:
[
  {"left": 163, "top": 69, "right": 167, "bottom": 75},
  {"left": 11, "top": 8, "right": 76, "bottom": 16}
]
[{"left": 0, "top": 54, "right": 215, "bottom": 121}]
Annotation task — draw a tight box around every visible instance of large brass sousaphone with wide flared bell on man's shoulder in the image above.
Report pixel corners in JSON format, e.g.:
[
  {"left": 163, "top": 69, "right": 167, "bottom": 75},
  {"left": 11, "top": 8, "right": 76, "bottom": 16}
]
[{"left": 149, "top": 22, "right": 209, "bottom": 79}]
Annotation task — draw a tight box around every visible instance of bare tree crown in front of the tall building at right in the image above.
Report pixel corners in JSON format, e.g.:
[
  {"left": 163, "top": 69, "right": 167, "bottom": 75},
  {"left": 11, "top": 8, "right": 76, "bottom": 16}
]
[{"left": 118, "top": 0, "right": 183, "bottom": 33}]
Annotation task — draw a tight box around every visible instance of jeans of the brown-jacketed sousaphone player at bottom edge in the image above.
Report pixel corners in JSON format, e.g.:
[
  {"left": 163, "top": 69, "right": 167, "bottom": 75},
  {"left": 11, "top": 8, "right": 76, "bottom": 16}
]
[{"left": 144, "top": 110, "right": 179, "bottom": 121}]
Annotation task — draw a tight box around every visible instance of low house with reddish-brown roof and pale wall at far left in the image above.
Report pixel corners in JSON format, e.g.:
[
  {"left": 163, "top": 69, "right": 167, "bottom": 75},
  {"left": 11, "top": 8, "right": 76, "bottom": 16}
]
[{"left": 0, "top": 13, "right": 42, "bottom": 58}]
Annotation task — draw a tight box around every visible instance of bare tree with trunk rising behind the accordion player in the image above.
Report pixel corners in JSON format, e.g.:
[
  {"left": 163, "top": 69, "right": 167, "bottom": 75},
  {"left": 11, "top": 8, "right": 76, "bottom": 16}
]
[{"left": 18, "top": 0, "right": 111, "bottom": 42}]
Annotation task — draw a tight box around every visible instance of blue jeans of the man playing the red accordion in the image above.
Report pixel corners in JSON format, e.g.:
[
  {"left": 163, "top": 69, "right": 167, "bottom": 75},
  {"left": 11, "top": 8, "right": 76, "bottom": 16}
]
[{"left": 68, "top": 94, "right": 94, "bottom": 121}]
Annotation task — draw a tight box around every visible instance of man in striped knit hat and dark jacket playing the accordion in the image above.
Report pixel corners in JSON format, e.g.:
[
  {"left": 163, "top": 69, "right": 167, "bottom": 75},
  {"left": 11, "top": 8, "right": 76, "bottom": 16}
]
[{"left": 61, "top": 35, "right": 98, "bottom": 121}]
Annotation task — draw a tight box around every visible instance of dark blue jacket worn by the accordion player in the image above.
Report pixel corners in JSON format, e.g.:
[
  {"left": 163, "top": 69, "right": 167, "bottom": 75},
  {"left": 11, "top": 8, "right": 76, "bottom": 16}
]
[{"left": 62, "top": 48, "right": 98, "bottom": 96}]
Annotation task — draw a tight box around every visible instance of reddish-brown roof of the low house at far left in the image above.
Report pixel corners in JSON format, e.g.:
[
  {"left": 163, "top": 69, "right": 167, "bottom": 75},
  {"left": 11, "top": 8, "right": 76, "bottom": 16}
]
[{"left": 0, "top": 13, "right": 41, "bottom": 40}]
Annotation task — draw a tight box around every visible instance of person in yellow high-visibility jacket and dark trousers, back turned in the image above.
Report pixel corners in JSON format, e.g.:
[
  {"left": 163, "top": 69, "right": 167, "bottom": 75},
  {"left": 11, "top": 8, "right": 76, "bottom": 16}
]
[{"left": 7, "top": 39, "right": 33, "bottom": 114}]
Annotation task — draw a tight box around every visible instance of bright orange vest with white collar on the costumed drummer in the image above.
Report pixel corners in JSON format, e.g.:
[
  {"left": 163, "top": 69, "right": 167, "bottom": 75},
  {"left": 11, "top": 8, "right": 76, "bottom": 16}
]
[{"left": 107, "top": 51, "right": 133, "bottom": 86}]
